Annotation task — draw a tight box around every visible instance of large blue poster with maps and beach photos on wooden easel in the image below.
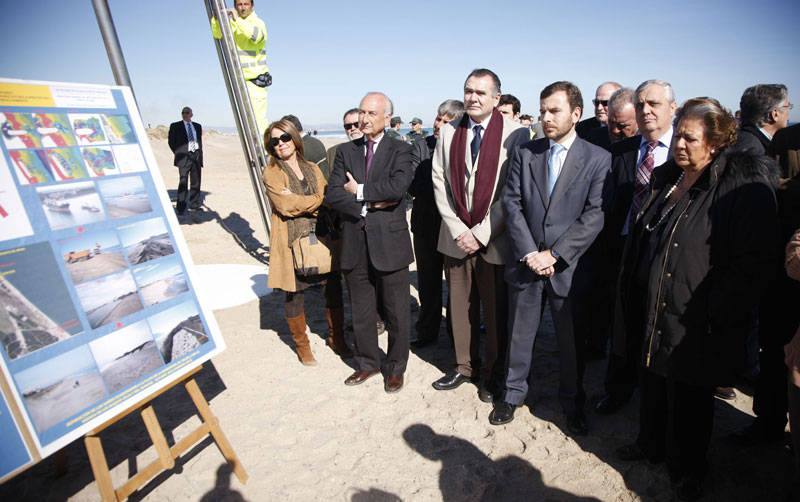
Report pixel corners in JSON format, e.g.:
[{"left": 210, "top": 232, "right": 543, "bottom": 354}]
[{"left": 0, "top": 79, "right": 224, "bottom": 466}]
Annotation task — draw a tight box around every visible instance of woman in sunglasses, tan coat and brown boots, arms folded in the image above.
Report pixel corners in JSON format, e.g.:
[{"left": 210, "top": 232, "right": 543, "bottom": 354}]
[{"left": 262, "top": 120, "right": 352, "bottom": 366}]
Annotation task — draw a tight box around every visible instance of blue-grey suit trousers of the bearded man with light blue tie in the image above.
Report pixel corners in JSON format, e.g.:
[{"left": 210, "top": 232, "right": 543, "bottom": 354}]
[{"left": 504, "top": 280, "right": 586, "bottom": 413}]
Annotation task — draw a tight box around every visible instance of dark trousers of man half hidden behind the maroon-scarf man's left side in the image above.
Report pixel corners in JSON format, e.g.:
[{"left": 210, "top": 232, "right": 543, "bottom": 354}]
[{"left": 414, "top": 226, "right": 444, "bottom": 339}]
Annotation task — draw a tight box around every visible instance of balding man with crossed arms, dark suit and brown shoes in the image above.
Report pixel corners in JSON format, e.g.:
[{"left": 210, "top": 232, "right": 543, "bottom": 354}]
[{"left": 325, "top": 92, "right": 414, "bottom": 392}]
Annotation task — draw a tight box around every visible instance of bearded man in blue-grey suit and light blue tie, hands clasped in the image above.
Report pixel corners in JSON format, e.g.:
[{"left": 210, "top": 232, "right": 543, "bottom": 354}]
[{"left": 489, "top": 82, "right": 611, "bottom": 434}]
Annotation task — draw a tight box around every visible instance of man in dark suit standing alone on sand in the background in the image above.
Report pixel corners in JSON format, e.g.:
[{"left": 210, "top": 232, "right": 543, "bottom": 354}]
[{"left": 167, "top": 106, "right": 203, "bottom": 214}]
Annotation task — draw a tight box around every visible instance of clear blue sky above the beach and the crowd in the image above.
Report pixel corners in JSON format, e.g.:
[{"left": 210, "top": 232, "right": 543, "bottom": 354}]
[{"left": 0, "top": 0, "right": 800, "bottom": 129}]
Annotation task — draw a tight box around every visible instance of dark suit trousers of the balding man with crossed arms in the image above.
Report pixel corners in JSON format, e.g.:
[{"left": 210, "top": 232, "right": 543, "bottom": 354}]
[{"left": 344, "top": 229, "right": 411, "bottom": 375}]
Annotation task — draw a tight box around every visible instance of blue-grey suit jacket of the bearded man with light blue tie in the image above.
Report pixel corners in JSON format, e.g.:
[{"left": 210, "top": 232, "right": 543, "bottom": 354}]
[{"left": 503, "top": 138, "right": 611, "bottom": 296}]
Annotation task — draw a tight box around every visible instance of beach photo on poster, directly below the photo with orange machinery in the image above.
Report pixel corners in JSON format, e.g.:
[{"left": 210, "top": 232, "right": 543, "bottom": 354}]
[{"left": 75, "top": 270, "right": 144, "bottom": 328}]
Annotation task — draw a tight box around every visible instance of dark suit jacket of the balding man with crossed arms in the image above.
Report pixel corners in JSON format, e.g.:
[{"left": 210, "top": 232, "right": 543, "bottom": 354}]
[{"left": 325, "top": 135, "right": 414, "bottom": 272}]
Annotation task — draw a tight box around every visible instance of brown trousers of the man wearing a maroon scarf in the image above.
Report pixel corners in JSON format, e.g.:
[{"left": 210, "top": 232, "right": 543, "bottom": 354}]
[{"left": 444, "top": 253, "right": 508, "bottom": 391}]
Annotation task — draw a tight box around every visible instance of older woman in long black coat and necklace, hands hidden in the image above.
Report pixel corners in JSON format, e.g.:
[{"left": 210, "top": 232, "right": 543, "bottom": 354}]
[{"left": 618, "top": 98, "right": 778, "bottom": 500}]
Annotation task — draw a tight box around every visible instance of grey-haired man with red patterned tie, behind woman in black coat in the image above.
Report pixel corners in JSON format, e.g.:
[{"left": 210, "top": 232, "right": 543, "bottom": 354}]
[{"left": 589, "top": 80, "right": 678, "bottom": 414}]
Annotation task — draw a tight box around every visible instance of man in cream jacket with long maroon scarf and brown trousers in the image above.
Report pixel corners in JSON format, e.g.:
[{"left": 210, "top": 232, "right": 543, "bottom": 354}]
[{"left": 432, "top": 69, "right": 528, "bottom": 402}]
